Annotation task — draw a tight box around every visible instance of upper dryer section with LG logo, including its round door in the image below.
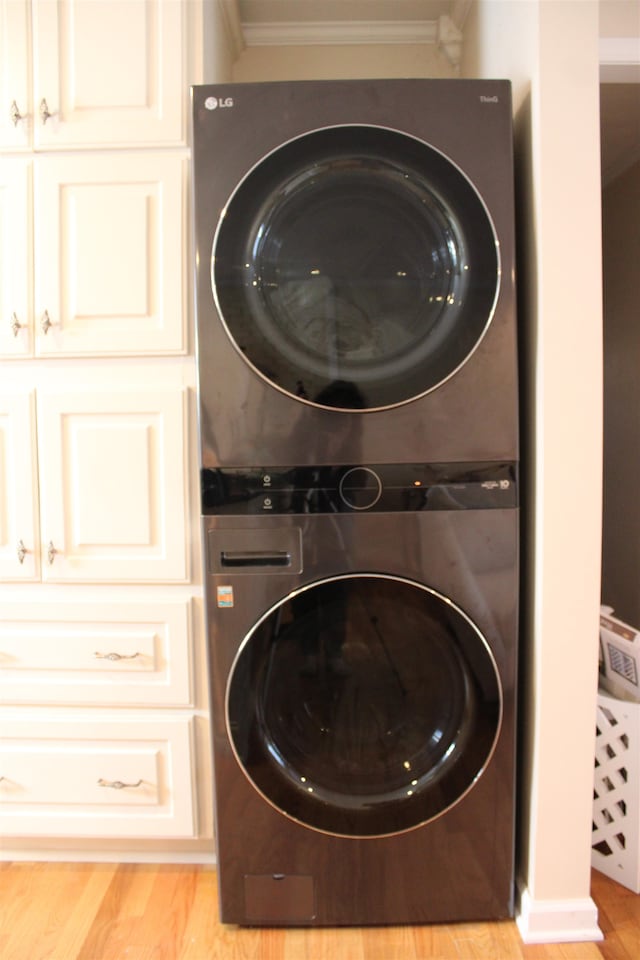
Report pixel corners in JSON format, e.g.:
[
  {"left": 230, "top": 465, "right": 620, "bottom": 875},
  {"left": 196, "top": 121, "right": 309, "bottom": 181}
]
[{"left": 193, "top": 80, "right": 518, "bottom": 469}]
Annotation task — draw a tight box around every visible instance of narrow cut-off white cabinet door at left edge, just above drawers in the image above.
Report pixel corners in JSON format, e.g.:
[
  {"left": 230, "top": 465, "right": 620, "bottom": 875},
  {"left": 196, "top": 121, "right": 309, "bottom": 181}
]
[{"left": 0, "top": 392, "right": 40, "bottom": 580}]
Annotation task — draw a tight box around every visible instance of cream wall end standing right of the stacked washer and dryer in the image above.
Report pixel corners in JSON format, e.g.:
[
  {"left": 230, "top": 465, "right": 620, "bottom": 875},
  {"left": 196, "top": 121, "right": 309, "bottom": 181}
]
[{"left": 463, "top": 0, "right": 602, "bottom": 939}]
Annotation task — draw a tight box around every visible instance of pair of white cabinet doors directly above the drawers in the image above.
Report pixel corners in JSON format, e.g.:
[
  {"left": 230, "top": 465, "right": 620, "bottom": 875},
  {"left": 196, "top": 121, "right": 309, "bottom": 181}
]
[{"left": 0, "top": 387, "right": 189, "bottom": 583}]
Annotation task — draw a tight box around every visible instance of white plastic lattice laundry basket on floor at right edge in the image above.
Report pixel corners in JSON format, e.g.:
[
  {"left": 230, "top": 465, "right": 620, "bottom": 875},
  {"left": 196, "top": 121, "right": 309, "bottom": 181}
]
[{"left": 591, "top": 693, "right": 640, "bottom": 893}]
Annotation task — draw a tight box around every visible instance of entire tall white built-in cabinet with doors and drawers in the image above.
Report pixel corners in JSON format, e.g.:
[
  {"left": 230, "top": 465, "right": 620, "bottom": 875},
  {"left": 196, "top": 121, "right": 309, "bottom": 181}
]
[{"left": 0, "top": 0, "right": 211, "bottom": 857}]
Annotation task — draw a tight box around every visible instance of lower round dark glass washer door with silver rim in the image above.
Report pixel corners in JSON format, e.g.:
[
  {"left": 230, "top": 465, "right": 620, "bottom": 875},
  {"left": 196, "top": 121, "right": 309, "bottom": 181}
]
[{"left": 227, "top": 574, "right": 502, "bottom": 837}]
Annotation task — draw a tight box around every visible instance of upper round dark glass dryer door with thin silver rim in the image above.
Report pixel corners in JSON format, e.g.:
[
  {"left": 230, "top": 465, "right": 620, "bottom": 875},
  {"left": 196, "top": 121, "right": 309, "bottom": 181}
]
[{"left": 212, "top": 126, "right": 500, "bottom": 410}]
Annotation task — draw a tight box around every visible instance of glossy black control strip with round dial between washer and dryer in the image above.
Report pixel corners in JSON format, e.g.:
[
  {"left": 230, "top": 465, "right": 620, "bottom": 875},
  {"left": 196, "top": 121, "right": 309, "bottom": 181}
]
[{"left": 201, "top": 462, "right": 518, "bottom": 516}]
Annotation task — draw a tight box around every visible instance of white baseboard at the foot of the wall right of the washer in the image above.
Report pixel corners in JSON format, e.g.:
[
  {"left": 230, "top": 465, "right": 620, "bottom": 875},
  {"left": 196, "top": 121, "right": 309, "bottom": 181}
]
[{"left": 516, "top": 890, "right": 604, "bottom": 943}]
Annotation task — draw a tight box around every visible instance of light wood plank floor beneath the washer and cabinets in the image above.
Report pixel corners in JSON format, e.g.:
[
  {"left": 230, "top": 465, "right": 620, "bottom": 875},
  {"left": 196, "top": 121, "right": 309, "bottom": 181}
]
[{"left": 0, "top": 863, "right": 640, "bottom": 960}]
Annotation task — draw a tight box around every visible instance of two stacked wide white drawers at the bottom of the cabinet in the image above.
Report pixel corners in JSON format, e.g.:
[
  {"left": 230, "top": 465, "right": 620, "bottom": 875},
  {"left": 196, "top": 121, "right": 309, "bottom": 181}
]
[{"left": 0, "top": 601, "right": 196, "bottom": 837}]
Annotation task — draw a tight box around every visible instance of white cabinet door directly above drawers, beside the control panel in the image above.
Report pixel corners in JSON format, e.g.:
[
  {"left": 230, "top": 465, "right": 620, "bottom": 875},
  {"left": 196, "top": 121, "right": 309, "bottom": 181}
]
[{"left": 38, "top": 388, "right": 188, "bottom": 583}]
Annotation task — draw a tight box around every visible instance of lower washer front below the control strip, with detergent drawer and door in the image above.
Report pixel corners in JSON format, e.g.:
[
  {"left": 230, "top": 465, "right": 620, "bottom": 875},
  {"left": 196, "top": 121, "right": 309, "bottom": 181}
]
[{"left": 203, "top": 508, "right": 519, "bottom": 925}]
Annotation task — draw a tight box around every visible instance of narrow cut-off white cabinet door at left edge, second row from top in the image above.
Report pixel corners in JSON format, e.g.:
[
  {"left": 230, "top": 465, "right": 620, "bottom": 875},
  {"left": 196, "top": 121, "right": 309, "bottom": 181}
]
[{"left": 0, "top": 159, "right": 32, "bottom": 357}]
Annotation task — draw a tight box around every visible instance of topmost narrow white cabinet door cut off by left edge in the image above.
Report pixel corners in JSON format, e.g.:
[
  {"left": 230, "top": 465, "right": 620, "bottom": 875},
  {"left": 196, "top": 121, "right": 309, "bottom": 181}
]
[{"left": 0, "top": 0, "right": 33, "bottom": 150}]
